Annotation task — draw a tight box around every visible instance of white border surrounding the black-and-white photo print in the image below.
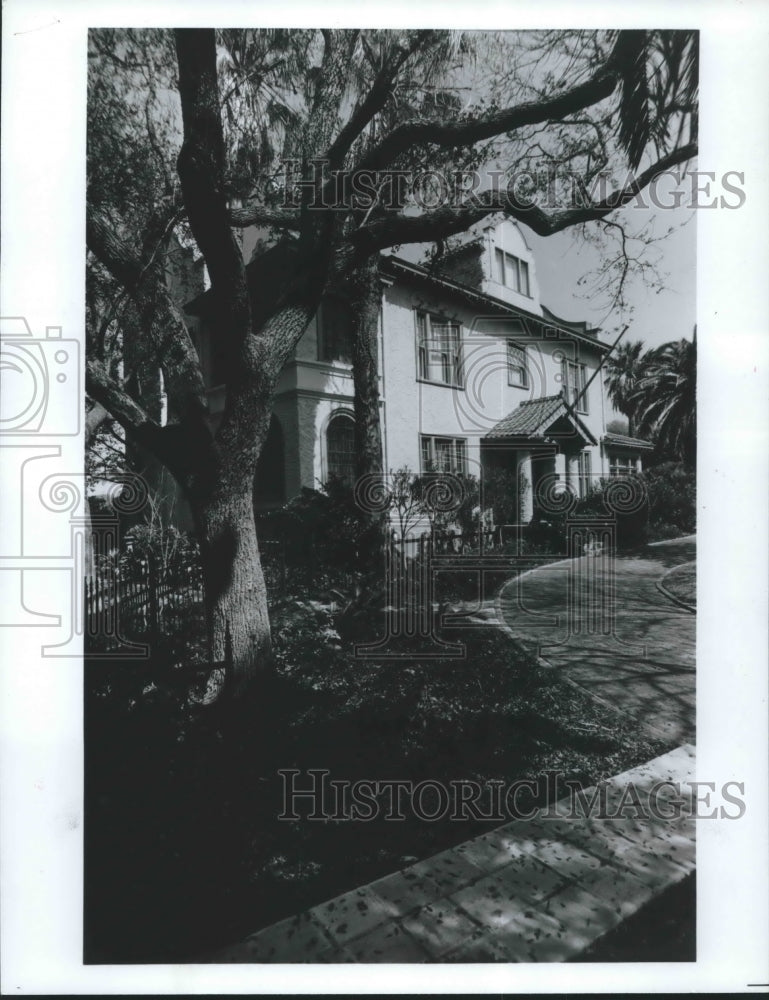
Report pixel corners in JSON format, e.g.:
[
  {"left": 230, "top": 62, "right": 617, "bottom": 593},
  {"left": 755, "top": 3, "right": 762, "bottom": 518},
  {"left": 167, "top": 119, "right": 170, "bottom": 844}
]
[{"left": 0, "top": 0, "right": 769, "bottom": 995}]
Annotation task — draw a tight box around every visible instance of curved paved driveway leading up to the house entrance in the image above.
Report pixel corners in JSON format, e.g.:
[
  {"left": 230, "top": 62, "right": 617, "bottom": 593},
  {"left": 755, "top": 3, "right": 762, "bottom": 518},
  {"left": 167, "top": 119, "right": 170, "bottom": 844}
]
[{"left": 498, "top": 535, "right": 696, "bottom": 746}]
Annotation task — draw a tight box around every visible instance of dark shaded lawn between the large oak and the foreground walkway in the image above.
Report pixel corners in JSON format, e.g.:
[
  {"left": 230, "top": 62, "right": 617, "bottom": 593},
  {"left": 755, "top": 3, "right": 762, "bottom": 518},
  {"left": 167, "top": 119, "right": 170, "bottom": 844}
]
[{"left": 85, "top": 596, "right": 669, "bottom": 963}]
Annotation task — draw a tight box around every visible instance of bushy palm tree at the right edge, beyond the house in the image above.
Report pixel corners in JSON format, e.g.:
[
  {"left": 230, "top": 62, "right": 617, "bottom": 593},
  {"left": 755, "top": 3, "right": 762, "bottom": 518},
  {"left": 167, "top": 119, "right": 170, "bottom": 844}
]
[{"left": 630, "top": 327, "right": 697, "bottom": 469}]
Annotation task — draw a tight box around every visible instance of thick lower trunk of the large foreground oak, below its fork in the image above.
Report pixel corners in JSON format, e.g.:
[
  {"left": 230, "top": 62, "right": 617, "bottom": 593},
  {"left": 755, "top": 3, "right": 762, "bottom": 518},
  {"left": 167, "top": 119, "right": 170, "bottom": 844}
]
[{"left": 194, "top": 482, "right": 272, "bottom": 695}]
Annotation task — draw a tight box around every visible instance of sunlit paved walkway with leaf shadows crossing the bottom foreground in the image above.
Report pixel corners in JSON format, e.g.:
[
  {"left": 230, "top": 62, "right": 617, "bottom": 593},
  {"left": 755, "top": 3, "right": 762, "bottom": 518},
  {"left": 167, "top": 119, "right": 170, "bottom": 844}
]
[{"left": 203, "top": 745, "right": 695, "bottom": 963}]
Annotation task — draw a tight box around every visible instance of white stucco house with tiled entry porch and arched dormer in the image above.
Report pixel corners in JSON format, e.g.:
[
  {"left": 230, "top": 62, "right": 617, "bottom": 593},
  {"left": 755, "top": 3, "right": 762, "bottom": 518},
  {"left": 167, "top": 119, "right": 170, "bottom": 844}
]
[{"left": 178, "top": 218, "right": 651, "bottom": 521}]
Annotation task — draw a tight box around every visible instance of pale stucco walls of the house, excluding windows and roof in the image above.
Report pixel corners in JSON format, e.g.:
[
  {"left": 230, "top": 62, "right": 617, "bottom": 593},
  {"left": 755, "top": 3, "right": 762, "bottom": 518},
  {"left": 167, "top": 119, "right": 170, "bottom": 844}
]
[{"left": 170, "top": 221, "right": 608, "bottom": 532}]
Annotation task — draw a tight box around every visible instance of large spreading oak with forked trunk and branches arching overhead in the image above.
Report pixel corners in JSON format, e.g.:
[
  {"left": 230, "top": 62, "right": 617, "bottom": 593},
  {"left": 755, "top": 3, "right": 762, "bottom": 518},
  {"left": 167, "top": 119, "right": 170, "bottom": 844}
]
[{"left": 86, "top": 29, "right": 697, "bottom": 690}]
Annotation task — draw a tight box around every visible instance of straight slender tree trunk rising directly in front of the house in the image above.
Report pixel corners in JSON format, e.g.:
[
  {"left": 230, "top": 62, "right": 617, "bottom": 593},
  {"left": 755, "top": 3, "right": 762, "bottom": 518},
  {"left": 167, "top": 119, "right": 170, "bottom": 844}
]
[{"left": 348, "top": 256, "right": 387, "bottom": 574}]
